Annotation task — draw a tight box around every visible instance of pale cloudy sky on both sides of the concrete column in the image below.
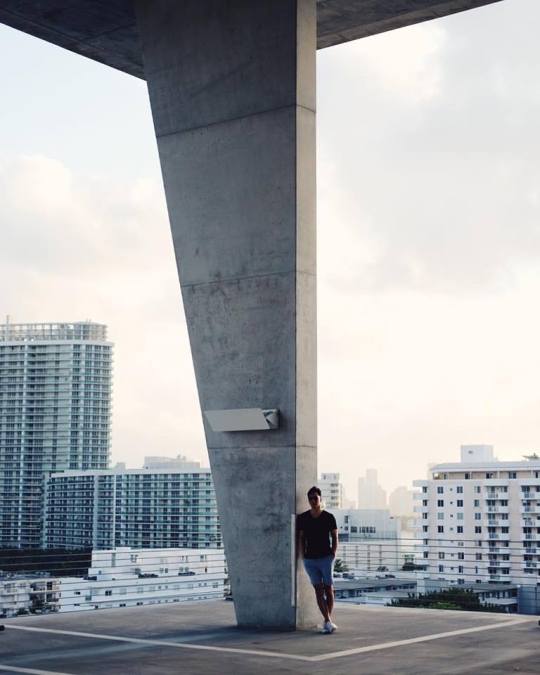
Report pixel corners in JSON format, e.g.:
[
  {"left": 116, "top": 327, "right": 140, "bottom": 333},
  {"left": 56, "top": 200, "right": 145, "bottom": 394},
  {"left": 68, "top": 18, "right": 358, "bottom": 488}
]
[{"left": 0, "top": 0, "right": 540, "bottom": 498}]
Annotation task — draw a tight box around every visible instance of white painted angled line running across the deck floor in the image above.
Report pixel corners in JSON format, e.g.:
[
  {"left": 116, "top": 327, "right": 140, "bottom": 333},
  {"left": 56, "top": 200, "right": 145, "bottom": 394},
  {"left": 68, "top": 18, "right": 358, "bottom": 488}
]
[{"left": 5, "top": 619, "right": 536, "bottom": 664}]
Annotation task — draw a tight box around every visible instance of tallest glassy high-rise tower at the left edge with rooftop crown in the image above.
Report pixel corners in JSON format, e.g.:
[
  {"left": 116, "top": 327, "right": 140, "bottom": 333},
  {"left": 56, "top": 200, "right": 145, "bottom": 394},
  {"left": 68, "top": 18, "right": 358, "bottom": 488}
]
[{"left": 0, "top": 321, "right": 112, "bottom": 548}]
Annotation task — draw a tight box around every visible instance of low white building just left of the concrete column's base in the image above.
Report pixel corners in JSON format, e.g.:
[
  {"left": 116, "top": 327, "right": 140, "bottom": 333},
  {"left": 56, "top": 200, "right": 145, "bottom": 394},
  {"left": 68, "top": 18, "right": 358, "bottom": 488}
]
[{"left": 55, "top": 548, "right": 227, "bottom": 612}]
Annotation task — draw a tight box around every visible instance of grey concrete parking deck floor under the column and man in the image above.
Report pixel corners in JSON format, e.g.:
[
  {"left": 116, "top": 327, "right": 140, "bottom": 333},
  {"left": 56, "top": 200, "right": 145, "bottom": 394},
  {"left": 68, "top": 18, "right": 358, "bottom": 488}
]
[{"left": 0, "top": 598, "right": 540, "bottom": 675}]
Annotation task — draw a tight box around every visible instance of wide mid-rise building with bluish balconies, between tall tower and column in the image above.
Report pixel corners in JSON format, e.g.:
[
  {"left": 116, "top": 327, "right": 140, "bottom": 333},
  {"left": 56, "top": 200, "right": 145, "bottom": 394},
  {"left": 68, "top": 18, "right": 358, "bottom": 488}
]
[{"left": 43, "top": 468, "right": 222, "bottom": 550}]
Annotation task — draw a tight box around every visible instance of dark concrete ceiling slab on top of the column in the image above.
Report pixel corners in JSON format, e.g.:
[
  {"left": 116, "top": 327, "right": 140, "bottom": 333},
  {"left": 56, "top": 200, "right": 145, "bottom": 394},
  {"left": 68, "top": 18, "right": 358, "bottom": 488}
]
[{"left": 0, "top": 0, "right": 501, "bottom": 78}]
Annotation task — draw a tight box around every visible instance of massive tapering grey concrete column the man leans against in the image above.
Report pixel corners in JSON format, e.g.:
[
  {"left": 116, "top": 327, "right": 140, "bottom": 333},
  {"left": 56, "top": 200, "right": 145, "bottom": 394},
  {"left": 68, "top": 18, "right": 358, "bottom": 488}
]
[{"left": 136, "top": 0, "right": 317, "bottom": 630}]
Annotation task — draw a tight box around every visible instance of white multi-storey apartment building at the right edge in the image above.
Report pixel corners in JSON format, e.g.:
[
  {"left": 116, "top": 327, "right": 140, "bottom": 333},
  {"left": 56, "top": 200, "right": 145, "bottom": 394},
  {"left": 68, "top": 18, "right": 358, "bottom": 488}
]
[{"left": 414, "top": 445, "right": 540, "bottom": 584}]
